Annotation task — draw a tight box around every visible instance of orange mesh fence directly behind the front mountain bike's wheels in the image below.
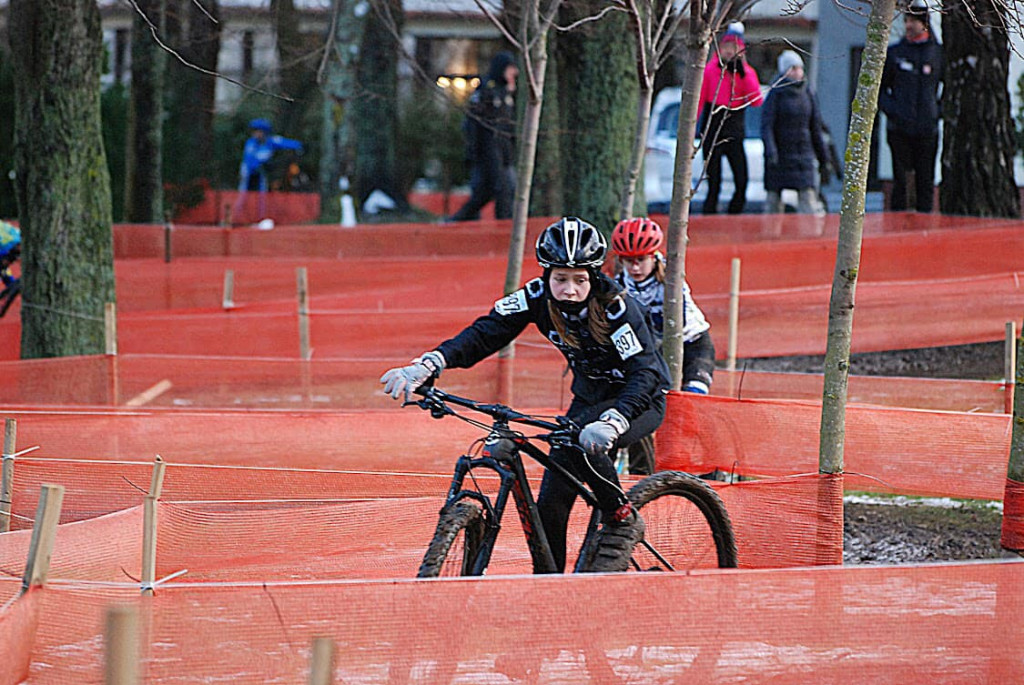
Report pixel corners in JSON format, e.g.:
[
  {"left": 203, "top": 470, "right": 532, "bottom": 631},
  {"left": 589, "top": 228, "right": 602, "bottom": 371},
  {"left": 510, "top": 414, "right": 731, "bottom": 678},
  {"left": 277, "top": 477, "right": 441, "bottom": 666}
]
[{"left": 0, "top": 460, "right": 843, "bottom": 581}]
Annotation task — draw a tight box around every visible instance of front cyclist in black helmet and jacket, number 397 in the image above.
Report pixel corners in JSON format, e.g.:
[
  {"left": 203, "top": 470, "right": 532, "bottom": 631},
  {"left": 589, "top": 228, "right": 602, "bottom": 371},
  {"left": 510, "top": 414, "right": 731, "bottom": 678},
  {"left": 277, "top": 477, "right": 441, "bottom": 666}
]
[{"left": 381, "top": 217, "right": 670, "bottom": 572}]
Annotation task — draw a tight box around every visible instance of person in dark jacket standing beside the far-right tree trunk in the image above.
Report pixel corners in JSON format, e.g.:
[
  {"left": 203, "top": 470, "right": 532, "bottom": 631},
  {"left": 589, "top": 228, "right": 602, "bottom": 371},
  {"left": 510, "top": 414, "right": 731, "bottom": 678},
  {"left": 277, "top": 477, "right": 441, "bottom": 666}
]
[{"left": 879, "top": 0, "right": 943, "bottom": 213}]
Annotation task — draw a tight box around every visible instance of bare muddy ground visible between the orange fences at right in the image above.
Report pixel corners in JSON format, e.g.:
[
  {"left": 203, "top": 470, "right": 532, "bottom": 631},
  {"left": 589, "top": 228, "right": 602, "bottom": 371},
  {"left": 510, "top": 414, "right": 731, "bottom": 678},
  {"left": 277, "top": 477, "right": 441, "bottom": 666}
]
[{"left": 739, "top": 342, "right": 1005, "bottom": 564}]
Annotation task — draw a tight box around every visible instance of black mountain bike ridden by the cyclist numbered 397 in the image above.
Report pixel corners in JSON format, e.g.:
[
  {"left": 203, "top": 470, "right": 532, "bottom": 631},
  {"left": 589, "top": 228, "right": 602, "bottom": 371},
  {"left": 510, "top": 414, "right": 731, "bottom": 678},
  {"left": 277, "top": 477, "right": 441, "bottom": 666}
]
[{"left": 407, "top": 385, "right": 736, "bottom": 577}]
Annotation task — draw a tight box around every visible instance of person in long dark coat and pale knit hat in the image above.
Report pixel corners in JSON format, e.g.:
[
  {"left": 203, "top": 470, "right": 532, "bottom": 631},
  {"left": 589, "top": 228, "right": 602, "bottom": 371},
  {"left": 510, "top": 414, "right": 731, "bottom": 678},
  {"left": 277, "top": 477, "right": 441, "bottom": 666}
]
[{"left": 761, "top": 50, "right": 827, "bottom": 214}]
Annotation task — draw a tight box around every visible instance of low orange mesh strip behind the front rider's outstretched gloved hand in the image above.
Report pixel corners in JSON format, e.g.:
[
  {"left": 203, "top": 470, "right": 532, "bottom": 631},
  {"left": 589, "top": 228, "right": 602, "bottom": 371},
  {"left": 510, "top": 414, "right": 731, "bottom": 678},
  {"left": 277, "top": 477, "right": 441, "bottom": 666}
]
[{"left": 0, "top": 352, "right": 1007, "bottom": 412}]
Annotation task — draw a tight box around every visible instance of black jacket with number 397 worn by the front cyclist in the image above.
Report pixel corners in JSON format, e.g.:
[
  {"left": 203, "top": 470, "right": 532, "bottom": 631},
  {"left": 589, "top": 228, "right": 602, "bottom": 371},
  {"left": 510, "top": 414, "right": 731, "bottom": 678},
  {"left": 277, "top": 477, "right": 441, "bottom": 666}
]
[{"left": 437, "top": 274, "right": 670, "bottom": 421}]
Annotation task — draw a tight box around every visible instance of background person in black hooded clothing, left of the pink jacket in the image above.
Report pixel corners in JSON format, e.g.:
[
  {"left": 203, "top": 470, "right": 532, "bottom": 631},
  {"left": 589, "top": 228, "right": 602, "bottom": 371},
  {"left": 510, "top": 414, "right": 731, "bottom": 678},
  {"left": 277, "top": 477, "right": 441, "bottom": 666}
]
[{"left": 449, "top": 52, "right": 519, "bottom": 221}]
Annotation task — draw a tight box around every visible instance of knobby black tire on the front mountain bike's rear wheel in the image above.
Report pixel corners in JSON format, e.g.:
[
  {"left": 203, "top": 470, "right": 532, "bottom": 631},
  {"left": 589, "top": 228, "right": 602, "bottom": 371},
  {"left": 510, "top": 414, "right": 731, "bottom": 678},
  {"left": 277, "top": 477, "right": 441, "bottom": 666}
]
[{"left": 629, "top": 471, "right": 736, "bottom": 570}]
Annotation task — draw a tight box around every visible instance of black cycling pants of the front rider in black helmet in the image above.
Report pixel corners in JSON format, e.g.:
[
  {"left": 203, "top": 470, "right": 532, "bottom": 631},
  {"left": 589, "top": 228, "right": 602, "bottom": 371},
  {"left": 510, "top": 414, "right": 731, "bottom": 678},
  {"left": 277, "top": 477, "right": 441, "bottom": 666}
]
[{"left": 537, "top": 395, "right": 665, "bottom": 572}]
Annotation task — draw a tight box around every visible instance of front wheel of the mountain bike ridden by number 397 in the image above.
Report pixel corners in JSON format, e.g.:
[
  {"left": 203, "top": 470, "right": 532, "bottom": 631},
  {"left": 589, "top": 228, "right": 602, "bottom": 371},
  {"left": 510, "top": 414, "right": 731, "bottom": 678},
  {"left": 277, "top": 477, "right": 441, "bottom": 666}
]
[{"left": 417, "top": 502, "right": 484, "bottom": 577}]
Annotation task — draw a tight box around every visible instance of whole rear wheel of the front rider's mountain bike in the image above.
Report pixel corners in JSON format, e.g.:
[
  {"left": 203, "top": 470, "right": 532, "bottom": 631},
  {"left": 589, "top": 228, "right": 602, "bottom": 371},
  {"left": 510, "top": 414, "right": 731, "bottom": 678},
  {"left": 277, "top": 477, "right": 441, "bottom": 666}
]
[{"left": 629, "top": 471, "right": 736, "bottom": 570}]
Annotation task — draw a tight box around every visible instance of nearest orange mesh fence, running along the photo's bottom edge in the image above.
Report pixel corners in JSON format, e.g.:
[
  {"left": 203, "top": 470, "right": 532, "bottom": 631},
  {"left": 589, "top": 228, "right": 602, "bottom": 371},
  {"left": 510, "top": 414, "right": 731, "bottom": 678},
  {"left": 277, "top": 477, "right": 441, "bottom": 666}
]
[{"left": 4, "top": 562, "right": 1024, "bottom": 685}]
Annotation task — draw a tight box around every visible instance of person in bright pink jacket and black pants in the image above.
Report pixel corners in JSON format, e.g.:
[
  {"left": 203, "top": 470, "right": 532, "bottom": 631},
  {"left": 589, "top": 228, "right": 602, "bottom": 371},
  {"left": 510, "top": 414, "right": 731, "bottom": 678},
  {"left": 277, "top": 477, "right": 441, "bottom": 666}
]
[{"left": 697, "top": 22, "right": 764, "bottom": 214}]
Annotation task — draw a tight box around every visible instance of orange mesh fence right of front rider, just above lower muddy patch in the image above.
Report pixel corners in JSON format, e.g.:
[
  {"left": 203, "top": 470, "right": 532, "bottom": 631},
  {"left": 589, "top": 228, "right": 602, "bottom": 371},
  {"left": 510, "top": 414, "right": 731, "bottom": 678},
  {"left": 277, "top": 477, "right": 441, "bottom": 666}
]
[{"left": 657, "top": 392, "right": 1011, "bottom": 500}]
